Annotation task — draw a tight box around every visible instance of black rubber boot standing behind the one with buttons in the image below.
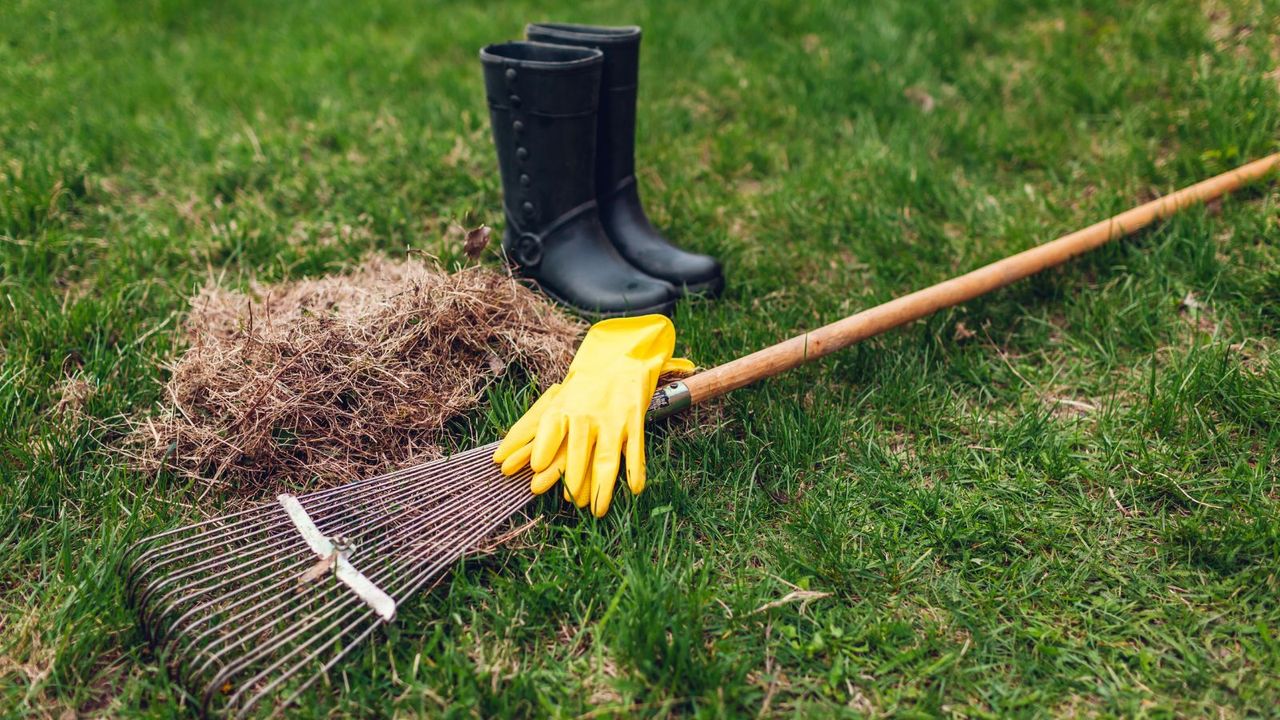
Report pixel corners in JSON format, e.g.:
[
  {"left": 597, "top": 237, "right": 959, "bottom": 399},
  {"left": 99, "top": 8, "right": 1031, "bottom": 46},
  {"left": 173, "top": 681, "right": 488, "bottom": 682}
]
[{"left": 525, "top": 23, "right": 724, "bottom": 295}]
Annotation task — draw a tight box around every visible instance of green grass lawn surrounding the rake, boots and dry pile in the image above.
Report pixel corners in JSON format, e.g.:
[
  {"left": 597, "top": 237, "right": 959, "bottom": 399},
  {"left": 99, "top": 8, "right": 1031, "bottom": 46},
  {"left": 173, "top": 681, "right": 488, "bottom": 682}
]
[{"left": 0, "top": 0, "right": 1280, "bottom": 717}]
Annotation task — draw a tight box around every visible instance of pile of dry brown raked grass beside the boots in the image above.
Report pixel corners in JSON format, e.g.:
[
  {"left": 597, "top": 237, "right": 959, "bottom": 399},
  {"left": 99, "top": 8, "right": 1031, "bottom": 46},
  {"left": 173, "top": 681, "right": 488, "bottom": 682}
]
[{"left": 131, "top": 258, "right": 582, "bottom": 492}]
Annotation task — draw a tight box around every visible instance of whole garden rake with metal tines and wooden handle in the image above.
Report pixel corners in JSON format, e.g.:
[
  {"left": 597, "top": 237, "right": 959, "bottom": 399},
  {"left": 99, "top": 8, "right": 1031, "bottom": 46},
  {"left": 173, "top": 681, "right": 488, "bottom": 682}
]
[{"left": 125, "top": 154, "right": 1280, "bottom": 717}]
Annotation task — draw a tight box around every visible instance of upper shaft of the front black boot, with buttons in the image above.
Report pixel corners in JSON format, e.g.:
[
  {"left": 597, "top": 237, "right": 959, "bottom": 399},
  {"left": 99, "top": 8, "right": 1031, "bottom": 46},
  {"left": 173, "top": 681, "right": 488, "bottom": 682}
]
[{"left": 480, "top": 41, "right": 603, "bottom": 233}]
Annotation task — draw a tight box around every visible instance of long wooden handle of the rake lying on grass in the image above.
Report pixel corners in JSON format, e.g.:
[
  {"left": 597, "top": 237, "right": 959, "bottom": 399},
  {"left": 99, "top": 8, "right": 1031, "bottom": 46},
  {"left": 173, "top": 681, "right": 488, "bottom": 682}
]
[{"left": 650, "top": 152, "right": 1280, "bottom": 416}]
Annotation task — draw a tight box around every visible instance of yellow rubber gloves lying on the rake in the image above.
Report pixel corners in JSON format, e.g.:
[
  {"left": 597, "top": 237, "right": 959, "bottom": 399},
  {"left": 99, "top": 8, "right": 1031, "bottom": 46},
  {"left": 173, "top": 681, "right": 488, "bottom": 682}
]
[{"left": 493, "top": 315, "right": 694, "bottom": 518}]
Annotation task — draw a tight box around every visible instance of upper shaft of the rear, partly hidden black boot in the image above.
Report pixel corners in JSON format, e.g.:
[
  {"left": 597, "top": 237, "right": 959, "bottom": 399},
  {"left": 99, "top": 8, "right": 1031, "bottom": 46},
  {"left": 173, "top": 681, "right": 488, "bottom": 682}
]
[{"left": 525, "top": 23, "right": 640, "bottom": 193}]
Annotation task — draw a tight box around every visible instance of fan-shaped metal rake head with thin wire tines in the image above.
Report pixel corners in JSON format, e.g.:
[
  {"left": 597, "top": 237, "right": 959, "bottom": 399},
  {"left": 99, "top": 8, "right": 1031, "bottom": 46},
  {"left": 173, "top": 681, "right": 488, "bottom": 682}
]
[{"left": 125, "top": 443, "right": 534, "bottom": 717}]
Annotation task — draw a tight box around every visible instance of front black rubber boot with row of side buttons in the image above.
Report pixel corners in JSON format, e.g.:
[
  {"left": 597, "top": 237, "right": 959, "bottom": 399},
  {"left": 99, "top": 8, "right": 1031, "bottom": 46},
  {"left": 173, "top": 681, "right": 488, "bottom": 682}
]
[{"left": 480, "top": 42, "right": 680, "bottom": 316}]
